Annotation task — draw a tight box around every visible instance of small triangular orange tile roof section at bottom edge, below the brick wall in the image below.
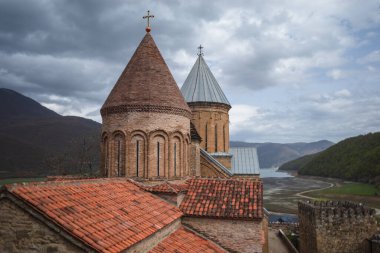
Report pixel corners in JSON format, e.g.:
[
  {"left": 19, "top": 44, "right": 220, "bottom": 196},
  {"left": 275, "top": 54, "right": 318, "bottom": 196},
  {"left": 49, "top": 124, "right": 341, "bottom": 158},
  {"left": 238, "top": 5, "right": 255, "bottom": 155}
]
[{"left": 150, "top": 227, "right": 226, "bottom": 253}]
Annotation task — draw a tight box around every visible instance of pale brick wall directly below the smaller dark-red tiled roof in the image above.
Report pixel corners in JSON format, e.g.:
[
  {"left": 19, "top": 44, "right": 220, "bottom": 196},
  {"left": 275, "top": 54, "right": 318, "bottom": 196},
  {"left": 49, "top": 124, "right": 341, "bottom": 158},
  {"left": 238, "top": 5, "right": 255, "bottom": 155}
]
[{"left": 182, "top": 217, "right": 265, "bottom": 253}]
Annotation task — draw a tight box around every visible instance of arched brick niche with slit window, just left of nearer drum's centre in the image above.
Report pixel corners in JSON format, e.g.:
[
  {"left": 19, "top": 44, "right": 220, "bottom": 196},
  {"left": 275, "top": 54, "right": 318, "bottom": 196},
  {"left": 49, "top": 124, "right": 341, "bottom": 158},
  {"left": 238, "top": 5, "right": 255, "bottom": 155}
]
[{"left": 129, "top": 135, "right": 145, "bottom": 177}]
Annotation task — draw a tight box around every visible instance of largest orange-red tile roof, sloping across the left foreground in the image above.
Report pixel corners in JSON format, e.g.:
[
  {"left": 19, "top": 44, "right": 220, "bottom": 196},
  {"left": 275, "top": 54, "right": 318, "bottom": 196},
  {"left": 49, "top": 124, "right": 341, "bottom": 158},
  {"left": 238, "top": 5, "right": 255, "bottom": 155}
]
[{"left": 6, "top": 179, "right": 182, "bottom": 253}]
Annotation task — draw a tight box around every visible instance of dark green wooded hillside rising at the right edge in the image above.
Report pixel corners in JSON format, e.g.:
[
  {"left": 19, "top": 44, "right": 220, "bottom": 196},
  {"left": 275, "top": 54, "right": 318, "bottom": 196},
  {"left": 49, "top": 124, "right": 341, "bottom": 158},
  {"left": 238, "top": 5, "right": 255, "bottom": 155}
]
[{"left": 280, "top": 132, "right": 380, "bottom": 182}]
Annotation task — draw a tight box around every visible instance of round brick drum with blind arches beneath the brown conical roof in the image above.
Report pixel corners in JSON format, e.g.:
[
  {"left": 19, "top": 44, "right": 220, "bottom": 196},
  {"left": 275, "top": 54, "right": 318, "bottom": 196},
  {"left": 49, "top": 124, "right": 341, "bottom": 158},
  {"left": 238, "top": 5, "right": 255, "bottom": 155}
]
[{"left": 101, "top": 112, "right": 190, "bottom": 179}]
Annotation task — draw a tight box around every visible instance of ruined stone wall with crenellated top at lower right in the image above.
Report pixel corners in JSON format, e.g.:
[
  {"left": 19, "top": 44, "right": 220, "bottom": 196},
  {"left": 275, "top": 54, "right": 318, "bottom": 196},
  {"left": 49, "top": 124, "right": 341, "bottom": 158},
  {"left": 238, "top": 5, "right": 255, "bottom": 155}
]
[{"left": 298, "top": 201, "right": 377, "bottom": 253}]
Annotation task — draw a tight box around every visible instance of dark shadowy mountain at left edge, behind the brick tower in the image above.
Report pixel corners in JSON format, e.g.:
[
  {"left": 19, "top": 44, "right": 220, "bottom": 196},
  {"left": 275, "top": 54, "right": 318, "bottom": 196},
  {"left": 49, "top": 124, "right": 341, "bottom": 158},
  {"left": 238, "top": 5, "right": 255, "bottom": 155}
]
[{"left": 0, "top": 88, "right": 101, "bottom": 178}]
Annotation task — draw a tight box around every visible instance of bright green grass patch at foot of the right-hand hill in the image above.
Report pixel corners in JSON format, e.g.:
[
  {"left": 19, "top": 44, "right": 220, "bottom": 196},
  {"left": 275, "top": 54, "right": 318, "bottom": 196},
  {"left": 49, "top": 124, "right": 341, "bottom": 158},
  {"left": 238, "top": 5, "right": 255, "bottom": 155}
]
[{"left": 310, "top": 183, "right": 380, "bottom": 197}]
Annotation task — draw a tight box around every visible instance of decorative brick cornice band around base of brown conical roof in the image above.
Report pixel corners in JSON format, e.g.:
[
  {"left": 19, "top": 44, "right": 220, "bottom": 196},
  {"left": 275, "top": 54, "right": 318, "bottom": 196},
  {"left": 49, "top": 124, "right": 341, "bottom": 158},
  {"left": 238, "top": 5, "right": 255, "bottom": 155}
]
[{"left": 100, "top": 105, "right": 191, "bottom": 119}]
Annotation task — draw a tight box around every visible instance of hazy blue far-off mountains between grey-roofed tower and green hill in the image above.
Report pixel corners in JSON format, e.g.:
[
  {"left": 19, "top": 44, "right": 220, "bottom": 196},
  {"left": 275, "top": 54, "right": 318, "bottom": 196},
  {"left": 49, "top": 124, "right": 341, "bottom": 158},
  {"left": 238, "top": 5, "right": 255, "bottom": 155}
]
[{"left": 231, "top": 140, "right": 334, "bottom": 168}]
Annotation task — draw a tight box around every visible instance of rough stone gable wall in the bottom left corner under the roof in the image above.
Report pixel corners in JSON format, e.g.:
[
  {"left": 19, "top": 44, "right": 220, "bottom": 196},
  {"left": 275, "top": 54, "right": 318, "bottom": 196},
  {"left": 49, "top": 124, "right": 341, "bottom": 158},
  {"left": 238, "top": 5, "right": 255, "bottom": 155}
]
[{"left": 0, "top": 199, "right": 84, "bottom": 253}]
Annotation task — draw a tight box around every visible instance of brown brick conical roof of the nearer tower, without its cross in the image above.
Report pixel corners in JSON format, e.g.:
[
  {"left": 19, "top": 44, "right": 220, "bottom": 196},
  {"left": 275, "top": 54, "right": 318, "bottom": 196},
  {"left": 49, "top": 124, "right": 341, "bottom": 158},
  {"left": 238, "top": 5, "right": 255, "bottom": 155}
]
[{"left": 101, "top": 33, "right": 191, "bottom": 118}]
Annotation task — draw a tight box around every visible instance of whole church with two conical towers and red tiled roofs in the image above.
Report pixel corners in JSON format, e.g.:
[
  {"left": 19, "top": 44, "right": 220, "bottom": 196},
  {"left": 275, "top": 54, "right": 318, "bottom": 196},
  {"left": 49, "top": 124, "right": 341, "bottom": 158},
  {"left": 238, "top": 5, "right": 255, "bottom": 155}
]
[{"left": 0, "top": 12, "right": 268, "bottom": 253}]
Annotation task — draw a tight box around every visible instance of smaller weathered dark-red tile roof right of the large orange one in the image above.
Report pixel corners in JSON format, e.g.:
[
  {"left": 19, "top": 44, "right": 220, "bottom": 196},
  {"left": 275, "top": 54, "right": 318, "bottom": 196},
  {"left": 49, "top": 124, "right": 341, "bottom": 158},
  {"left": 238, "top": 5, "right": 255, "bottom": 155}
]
[{"left": 180, "top": 179, "right": 263, "bottom": 219}]
